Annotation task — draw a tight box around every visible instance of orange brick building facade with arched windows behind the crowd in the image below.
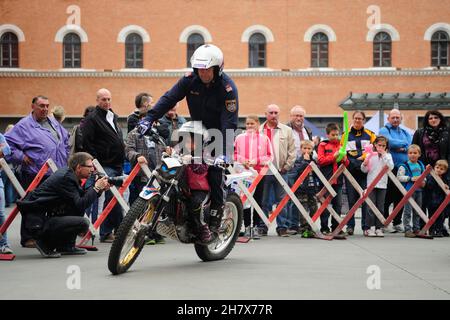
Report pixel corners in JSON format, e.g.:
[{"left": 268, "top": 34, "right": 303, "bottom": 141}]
[{"left": 0, "top": 0, "right": 450, "bottom": 129}]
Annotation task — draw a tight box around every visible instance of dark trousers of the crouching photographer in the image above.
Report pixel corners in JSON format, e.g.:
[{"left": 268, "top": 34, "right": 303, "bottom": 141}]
[{"left": 37, "top": 216, "right": 89, "bottom": 250}]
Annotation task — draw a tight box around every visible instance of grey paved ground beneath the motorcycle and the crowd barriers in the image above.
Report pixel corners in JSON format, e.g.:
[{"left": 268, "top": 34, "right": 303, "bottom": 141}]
[{"left": 0, "top": 208, "right": 450, "bottom": 300}]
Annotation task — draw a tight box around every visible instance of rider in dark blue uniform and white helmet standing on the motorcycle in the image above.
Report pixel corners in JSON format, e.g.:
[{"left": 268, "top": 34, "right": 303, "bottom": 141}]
[{"left": 138, "top": 44, "right": 239, "bottom": 231}]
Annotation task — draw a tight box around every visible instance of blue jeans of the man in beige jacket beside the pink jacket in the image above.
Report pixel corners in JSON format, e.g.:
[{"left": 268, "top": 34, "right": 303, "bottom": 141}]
[{"left": 262, "top": 174, "right": 289, "bottom": 229}]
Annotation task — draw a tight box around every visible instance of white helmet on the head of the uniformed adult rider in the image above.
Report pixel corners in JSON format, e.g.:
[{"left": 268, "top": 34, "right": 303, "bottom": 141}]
[{"left": 191, "top": 44, "right": 223, "bottom": 76}]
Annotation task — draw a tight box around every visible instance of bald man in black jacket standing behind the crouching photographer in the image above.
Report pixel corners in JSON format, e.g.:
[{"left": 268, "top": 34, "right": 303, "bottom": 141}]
[{"left": 81, "top": 89, "right": 125, "bottom": 242}]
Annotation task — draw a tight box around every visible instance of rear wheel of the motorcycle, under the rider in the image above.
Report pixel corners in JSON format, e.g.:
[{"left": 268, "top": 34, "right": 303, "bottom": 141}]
[{"left": 195, "top": 192, "right": 243, "bottom": 261}]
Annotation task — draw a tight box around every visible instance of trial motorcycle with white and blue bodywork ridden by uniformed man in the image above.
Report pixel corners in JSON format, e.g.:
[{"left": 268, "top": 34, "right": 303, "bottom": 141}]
[{"left": 108, "top": 129, "right": 248, "bottom": 275}]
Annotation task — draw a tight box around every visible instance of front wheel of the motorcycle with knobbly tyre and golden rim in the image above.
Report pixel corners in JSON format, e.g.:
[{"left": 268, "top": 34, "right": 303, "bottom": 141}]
[{"left": 108, "top": 196, "right": 159, "bottom": 275}]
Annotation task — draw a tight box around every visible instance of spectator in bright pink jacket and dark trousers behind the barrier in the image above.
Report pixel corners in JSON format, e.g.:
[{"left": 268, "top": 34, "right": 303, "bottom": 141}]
[{"left": 234, "top": 115, "right": 273, "bottom": 239}]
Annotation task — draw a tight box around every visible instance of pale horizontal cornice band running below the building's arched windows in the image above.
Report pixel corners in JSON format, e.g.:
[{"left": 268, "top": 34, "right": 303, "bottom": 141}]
[{"left": 0, "top": 68, "right": 450, "bottom": 78}]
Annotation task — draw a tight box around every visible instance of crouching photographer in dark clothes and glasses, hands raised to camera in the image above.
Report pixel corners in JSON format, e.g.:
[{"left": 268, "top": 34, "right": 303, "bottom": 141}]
[{"left": 17, "top": 152, "right": 110, "bottom": 258}]
